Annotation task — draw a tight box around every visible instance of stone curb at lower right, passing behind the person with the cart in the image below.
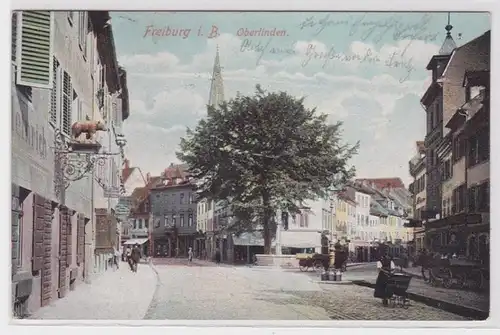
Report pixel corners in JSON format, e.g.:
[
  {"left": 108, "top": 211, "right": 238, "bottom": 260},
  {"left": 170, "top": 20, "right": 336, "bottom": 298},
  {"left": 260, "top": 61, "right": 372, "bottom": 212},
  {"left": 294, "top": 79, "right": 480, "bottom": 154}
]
[{"left": 352, "top": 280, "right": 490, "bottom": 320}]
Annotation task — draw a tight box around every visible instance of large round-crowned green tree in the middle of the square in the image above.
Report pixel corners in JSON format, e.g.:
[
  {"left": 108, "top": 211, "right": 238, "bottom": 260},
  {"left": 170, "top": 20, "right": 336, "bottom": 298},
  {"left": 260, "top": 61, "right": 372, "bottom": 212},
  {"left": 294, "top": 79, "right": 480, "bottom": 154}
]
[{"left": 177, "top": 85, "right": 358, "bottom": 254}]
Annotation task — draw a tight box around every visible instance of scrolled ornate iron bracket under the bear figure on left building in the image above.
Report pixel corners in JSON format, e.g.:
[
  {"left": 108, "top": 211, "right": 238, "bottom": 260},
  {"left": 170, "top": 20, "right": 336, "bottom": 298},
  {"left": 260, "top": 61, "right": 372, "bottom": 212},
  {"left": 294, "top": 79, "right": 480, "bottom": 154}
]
[{"left": 54, "top": 129, "right": 121, "bottom": 197}]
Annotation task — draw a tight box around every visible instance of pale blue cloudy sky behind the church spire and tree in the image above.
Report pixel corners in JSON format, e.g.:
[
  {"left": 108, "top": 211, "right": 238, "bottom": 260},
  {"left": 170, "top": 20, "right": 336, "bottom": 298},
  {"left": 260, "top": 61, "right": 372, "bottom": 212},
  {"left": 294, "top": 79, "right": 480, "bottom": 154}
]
[{"left": 112, "top": 12, "right": 491, "bottom": 184}]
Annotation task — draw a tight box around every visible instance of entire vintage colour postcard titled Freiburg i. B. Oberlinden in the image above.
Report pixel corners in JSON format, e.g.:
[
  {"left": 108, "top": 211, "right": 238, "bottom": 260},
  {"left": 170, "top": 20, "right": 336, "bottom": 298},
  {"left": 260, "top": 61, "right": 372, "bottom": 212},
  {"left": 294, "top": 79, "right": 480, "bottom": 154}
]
[{"left": 11, "top": 10, "right": 491, "bottom": 321}]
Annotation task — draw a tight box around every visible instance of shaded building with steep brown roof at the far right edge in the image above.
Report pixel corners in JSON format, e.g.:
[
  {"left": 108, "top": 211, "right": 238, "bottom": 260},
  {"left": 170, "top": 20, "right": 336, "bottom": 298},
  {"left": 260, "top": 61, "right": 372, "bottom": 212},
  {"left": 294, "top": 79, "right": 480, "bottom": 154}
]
[{"left": 425, "top": 31, "right": 491, "bottom": 264}]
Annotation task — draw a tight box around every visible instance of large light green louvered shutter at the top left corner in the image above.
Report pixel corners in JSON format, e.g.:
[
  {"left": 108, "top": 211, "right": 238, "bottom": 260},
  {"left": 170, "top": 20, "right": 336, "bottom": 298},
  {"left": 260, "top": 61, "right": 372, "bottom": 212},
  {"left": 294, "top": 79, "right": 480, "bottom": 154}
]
[{"left": 17, "top": 11, "right": 52, "bottom": 89}]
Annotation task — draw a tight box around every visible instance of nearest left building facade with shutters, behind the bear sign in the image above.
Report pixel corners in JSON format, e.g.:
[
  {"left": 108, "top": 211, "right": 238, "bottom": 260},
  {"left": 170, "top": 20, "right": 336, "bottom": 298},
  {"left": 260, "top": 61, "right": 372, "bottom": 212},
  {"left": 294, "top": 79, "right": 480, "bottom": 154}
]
[{"left": 11, "top": 11, "right": 128, "bottom": 314}]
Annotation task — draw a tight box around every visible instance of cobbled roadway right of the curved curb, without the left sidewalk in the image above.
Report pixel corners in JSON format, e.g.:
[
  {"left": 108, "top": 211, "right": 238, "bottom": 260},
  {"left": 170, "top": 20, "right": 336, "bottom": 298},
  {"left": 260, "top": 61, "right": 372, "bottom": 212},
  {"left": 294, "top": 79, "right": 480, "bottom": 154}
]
[{"left": 145, "top": 265, "right": 466, "bottom": 320}]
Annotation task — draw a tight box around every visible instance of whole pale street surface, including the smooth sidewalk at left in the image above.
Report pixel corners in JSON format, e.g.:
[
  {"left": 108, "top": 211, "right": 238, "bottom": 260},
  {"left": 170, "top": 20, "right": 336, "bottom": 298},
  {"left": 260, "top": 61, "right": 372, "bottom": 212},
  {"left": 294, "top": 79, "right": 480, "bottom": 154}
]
[{"left": 26, "top": 259, "right": 472, "bottom": 321}]
